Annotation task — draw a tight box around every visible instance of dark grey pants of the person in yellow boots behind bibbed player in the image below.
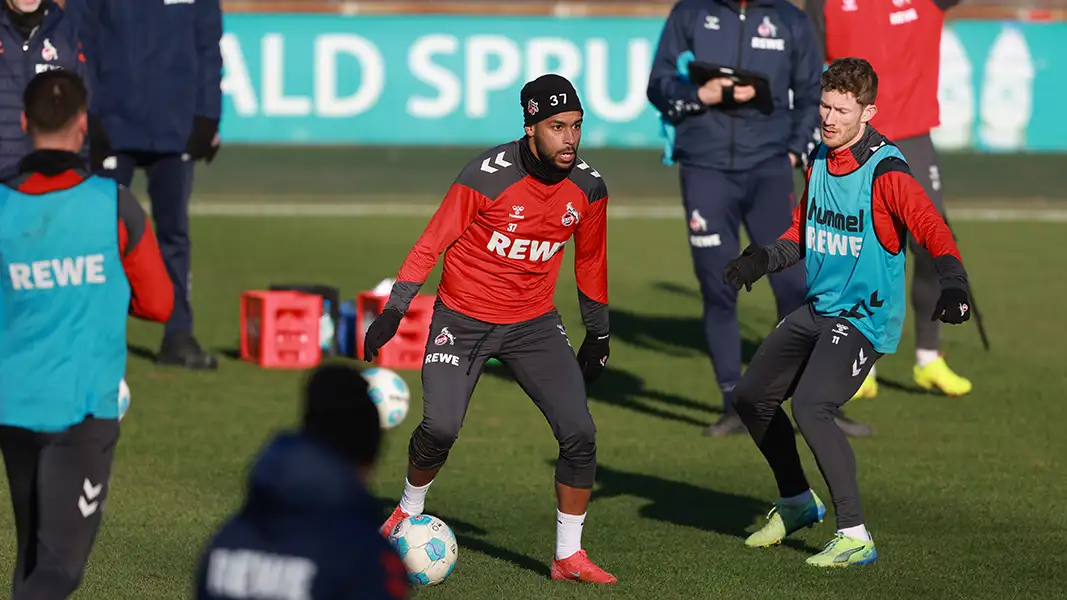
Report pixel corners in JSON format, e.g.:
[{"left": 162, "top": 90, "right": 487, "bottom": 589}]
[{"left": 894, "top": 133, "right": 945, "bottom": 350}]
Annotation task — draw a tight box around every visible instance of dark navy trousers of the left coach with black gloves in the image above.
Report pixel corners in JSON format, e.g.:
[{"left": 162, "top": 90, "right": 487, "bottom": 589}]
[{"left": 97, "top": 153, "right": 193, "bottom": 335}]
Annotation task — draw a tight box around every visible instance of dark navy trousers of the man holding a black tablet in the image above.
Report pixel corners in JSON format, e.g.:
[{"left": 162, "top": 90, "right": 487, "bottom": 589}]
[{"left": 681, "top": 156, "right": 806, "bottom": 410}]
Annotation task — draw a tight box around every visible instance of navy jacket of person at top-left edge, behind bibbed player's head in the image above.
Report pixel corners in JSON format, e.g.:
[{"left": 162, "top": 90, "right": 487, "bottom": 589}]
[{"left": 0, "top": 0, "right": 90, "bottom": 180}]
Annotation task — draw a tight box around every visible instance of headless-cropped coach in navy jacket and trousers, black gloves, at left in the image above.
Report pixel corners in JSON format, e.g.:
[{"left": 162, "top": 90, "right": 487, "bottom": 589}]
[{"left": 84, "top": 0, "right": 222, "bottom": 368}]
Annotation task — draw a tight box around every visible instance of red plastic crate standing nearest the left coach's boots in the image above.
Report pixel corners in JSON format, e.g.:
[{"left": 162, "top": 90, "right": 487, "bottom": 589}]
[{"left": 241, "top": 290, "right": 322, "bottom": 368}]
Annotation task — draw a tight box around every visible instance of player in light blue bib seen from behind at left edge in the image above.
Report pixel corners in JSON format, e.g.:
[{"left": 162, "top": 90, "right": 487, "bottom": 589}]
[{"left": 0, "top": 69, "right": 174, "bottom": 600}]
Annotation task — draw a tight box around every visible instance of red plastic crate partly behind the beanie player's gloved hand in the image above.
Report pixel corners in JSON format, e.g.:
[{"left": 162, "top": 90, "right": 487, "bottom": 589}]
[{"left": 355, "top": 291, "right": 437, "bottom": 370}]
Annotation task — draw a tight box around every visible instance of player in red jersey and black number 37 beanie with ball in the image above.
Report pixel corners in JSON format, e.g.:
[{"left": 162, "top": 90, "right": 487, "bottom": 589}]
[{"left": 364, "top": 75, "right": 616, "bottom": 584}]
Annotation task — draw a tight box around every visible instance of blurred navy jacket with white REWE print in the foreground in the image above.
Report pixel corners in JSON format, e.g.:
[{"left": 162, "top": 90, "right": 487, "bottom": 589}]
[{"left": 196, "top": 433, "right": 410, "bottom": 600}]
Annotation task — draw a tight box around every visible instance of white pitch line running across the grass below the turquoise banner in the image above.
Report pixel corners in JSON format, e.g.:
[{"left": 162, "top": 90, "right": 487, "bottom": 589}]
[{"left": 137, "top": 202, "right": 1067, "bottom": 223}]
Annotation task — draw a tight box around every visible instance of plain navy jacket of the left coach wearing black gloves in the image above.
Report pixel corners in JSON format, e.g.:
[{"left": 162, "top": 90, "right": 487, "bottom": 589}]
[{"left": 78, "top": 0, "right": 222, "bottom": 153}]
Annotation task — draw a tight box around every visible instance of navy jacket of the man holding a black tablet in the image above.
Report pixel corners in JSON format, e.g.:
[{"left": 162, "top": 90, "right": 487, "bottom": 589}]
[{"left": 648, "top": 0, "right": 823, "bottom": 171}]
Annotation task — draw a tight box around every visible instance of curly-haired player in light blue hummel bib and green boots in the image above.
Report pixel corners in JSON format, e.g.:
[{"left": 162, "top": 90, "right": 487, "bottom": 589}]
[{"left": 723, "top": 59, "right": 971, "bottom": 567}]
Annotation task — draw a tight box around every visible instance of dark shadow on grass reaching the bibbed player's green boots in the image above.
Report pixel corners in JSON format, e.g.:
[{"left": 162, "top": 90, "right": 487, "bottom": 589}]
[{"left": 592, "top": 463, "right": 822, "bottom": 552}]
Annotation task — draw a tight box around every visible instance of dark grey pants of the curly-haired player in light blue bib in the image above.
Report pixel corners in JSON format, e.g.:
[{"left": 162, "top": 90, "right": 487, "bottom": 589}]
[{"left": 734, "top": 304, "right": 881, "bottom": 528}]
